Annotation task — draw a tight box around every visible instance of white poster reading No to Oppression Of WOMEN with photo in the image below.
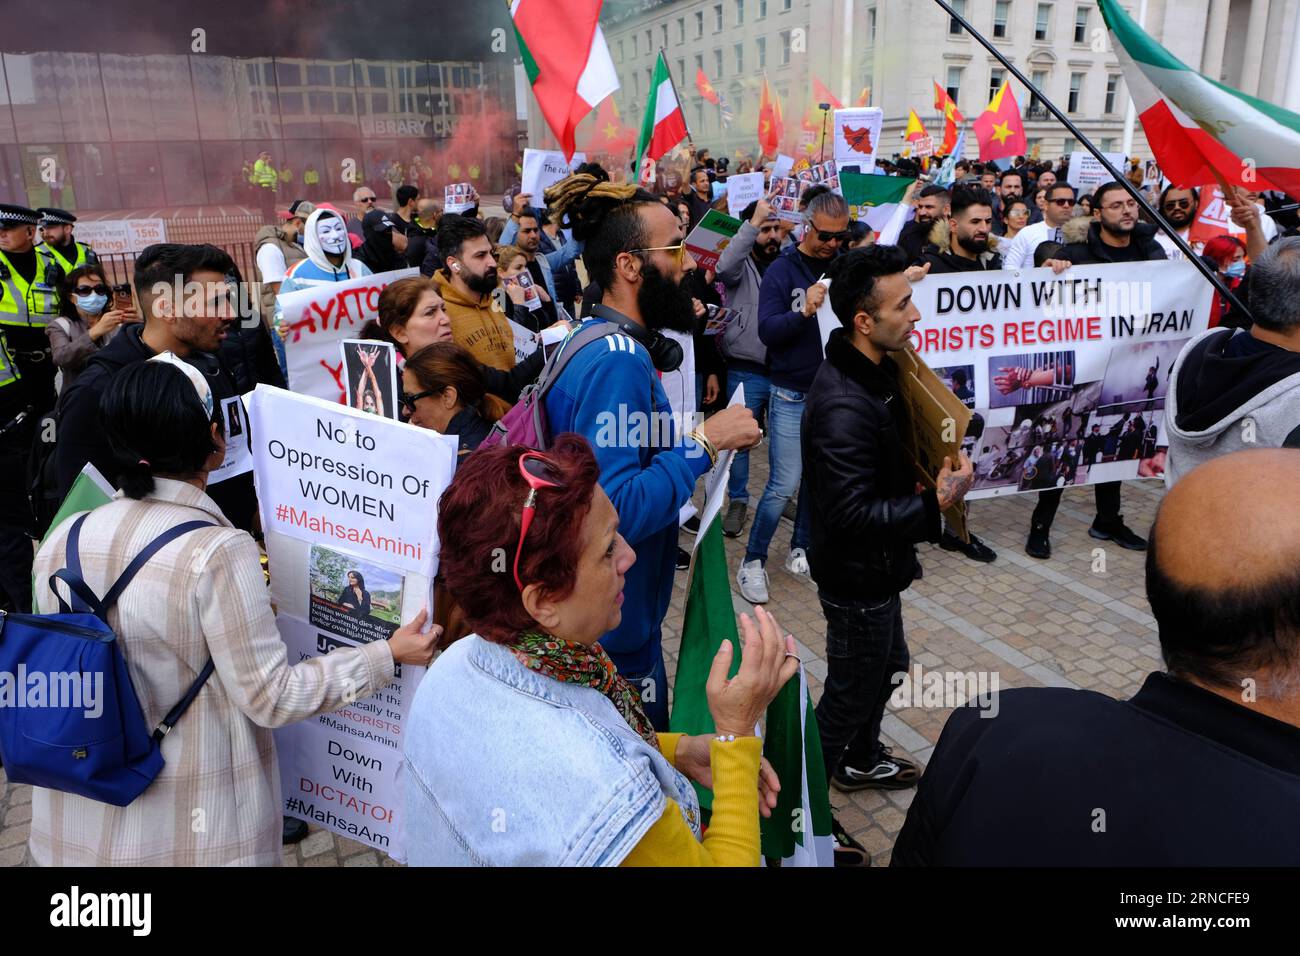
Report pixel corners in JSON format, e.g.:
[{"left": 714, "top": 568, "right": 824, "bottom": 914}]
[{"left": 248, "top": 385, "right": 458, "bottom": 860}]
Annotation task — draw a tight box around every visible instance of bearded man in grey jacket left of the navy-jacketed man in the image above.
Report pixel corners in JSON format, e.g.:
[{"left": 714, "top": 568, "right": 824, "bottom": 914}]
[{"left": 718, "top": 199, "right": 781, "bottom": 537}]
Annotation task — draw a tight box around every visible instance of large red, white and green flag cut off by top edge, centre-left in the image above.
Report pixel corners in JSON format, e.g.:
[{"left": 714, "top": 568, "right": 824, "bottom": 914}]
[{"left": 510, "top": 0, "right": 619, "bottom": 160}]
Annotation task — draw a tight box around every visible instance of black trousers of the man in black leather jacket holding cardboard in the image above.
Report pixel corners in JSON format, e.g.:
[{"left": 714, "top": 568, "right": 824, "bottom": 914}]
[{"left": 816, "top": 593, "right": 911, "bottom": 778}]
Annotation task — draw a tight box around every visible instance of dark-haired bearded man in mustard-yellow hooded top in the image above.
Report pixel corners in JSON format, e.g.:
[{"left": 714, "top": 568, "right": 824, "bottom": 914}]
[{"left": 433, "top": 213, "right": 515, "bottom": 372}]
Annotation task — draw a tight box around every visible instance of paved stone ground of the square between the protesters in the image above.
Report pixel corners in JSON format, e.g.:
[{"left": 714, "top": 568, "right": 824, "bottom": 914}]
[{"left": 0, "top": 444, "right": 1164, "bottom": 866}]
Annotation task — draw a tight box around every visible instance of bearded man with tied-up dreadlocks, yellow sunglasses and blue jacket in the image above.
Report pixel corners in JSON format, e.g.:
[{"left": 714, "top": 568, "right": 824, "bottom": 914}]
[{"left": 540, "top": 173, "right": 759, "bottom": 730}]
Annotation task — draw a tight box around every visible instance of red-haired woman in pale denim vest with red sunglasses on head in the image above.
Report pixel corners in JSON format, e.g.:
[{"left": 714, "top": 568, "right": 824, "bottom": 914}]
[{"left": 404, "top": 434, "right": 798, "bottom": 866}]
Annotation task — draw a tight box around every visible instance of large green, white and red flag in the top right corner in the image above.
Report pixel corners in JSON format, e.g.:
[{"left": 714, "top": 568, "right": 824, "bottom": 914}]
[{"left": 1099, "top": 0, "right": 1300, "bottom": 196}]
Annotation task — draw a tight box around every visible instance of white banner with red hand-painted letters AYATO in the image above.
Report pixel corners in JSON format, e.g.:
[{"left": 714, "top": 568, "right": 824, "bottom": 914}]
[{"left": 276, "top": 269, "right": 420, "bottom": 405}]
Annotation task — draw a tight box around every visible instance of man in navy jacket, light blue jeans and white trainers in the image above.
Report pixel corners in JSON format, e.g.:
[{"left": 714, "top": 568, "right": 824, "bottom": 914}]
[{"left": 736, "top": 193, "right": 852, "bottom": 604}]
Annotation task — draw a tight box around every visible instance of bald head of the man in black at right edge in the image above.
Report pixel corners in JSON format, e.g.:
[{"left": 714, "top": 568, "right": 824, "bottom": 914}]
[{"left": 1147, "top": 449, "right": 1300, "bottom": 696}]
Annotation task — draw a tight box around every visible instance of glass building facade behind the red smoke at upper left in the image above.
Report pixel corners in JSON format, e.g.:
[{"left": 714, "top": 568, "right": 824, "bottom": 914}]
[{"left": 0, "top": 52, "right": 519, "bottom": 211}]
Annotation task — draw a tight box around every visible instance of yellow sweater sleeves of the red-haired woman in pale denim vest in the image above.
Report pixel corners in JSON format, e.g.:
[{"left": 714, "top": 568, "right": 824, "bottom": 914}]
[{"left": 623, "top": 734, "right": 763, "bottom": 866}]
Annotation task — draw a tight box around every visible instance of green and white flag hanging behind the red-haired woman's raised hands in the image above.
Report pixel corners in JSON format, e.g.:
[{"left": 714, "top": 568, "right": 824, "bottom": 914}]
[{"left": 670, "top": 522, "right": 832, "bottom": 866}]
